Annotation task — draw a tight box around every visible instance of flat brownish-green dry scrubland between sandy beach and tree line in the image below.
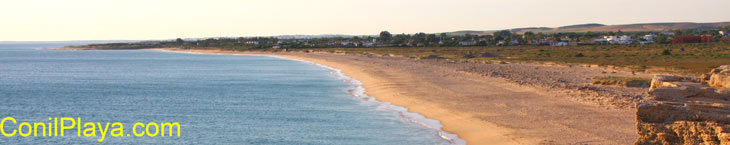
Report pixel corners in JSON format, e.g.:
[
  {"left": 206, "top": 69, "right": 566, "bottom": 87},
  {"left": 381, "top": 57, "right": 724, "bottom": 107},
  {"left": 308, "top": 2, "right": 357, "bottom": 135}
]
[{"left": 288, "top": 42, "right": 730, "bottom": 75}]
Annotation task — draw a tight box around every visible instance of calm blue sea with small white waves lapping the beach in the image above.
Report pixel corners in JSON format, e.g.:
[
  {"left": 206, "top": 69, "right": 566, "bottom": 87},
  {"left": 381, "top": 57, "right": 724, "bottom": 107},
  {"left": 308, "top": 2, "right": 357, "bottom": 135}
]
[{"left": 0, "top": 43, "right": 462, "bottom": 145}]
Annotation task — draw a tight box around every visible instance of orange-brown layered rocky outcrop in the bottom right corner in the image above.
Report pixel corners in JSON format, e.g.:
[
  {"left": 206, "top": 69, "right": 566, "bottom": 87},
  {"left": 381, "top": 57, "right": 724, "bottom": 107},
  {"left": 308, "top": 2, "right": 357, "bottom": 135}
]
[{"left": 635, "top": 67, "right": 730, "bottom": 145}]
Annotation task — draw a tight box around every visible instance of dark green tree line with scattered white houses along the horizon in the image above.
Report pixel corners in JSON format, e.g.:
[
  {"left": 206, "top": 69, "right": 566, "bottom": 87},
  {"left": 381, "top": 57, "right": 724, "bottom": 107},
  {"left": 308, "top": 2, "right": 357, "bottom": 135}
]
[{"left": 75, "top": 26, "right": 730, "bottom": 50}]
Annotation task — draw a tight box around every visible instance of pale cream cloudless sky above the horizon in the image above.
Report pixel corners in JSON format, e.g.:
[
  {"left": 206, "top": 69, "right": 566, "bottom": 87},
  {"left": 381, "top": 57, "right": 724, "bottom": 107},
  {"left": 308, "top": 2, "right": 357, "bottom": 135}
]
[{"left": 0, "top": 0, "right": 730, "bottom": 41}]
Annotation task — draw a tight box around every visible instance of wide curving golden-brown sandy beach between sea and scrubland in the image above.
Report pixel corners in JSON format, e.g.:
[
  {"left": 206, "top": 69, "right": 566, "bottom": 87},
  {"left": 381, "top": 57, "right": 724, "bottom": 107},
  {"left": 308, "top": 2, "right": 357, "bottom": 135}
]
[{"left": 135, "top": 49, "right": 636, "bottom": 144}]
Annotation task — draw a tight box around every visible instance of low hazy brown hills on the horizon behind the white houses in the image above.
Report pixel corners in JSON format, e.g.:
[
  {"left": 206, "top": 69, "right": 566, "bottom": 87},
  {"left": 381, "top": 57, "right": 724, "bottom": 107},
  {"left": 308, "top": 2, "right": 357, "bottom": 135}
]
[{"left": 447, "top": 22, "right": 730, "bottom": 35}]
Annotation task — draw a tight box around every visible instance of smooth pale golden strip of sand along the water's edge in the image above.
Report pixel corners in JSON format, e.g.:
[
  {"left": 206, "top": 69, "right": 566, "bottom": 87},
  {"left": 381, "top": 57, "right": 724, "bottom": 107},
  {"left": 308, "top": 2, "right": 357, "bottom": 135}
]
[{"left": 152, "top": 48, "right": 542, "bottom": 145}]
